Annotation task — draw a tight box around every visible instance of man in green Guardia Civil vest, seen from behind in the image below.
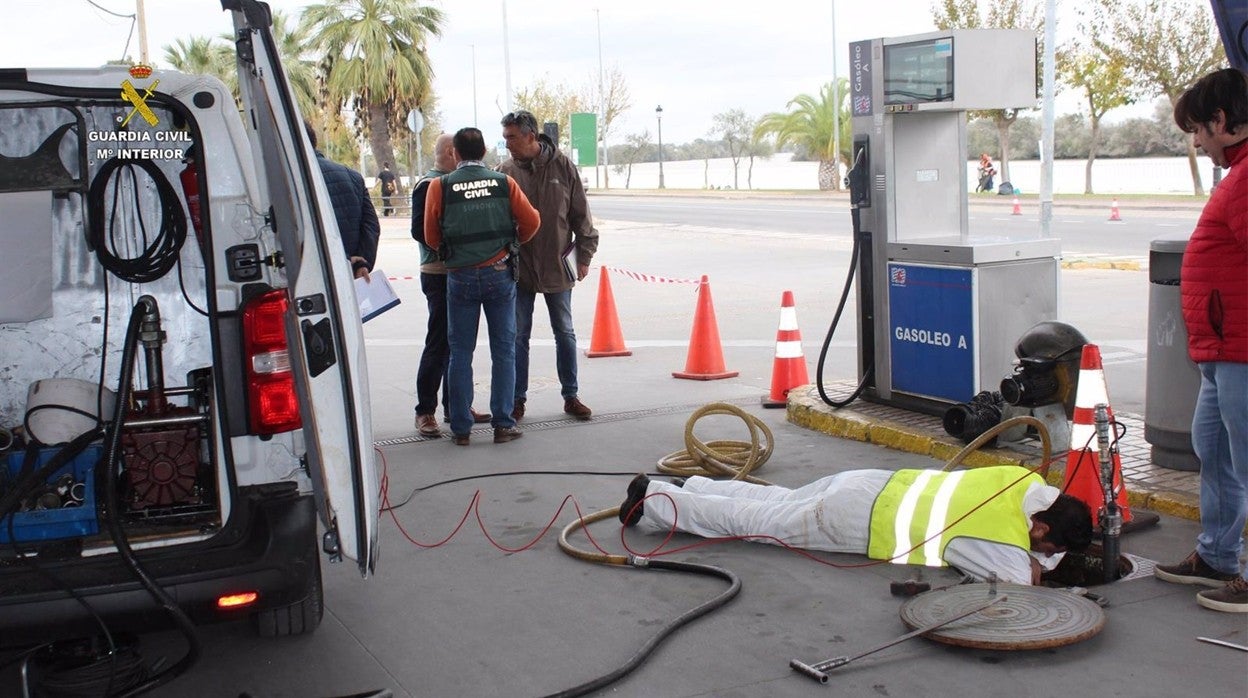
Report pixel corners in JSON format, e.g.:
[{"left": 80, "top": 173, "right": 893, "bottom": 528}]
[{"left": 424, "top": 127, "right": 542, "bottom": 446}]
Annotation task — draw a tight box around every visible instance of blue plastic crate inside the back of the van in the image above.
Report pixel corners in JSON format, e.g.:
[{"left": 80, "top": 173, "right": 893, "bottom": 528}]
[{"left": 0, "top": 445, "right": 104, "bottom": 543}]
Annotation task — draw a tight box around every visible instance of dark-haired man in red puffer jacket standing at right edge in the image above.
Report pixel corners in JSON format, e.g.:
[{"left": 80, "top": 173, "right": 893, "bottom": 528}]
[{"left": 1154, "top": 67, "right": 1248, "bottom": 613}]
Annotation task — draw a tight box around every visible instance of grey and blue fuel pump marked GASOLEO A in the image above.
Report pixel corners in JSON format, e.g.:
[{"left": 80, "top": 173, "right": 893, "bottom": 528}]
[{"left": 850, "top": 29, "right": 1061, "bottom": 415}]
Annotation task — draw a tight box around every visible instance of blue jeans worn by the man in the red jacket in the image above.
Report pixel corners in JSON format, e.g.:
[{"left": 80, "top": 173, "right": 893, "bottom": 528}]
[{"left": 1192, "top": 361, "right": 1248, "bottom": 573}]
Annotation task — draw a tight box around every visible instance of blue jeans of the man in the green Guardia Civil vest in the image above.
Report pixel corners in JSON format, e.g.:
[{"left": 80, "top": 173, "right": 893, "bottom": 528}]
[{"left": 447, "top": 265, "right": 515, "bottom": 435}]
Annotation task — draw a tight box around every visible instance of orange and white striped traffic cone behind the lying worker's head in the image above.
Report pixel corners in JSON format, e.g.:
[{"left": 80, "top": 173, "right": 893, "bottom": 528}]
[{"left": 1062, "top": 345, "right": 1132, "bottom": 527}]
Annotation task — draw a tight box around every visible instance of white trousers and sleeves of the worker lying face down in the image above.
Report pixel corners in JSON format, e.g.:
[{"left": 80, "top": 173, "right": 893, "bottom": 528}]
[{"left": 638, "top": 469, "right": 1063, "bottom": 584}]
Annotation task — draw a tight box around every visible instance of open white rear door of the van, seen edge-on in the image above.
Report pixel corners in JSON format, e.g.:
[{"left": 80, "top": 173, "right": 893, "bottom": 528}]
[{"left": 221, "top": 0, "right": 379, "bottom": 576}]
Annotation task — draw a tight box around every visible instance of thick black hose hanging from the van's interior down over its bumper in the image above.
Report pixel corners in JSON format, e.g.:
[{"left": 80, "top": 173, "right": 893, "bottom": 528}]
[{"left": 104, "top": 296, "right": 200, "bottom": 698}]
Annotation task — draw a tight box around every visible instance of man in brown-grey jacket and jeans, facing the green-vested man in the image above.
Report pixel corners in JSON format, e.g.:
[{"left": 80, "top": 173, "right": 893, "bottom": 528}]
[{"left": 498, "top": 111, "right": 598, "bottom": 421}]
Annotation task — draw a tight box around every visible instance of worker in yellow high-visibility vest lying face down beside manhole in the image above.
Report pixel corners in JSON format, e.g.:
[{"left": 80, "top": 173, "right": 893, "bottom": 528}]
[{"left": 619, "top": 466, "right": 1092, "bottom": 584}]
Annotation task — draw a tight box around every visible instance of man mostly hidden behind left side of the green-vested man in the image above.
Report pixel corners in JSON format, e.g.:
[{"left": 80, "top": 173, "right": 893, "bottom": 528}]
[{"left": 412, "top": 134, "right": 489, "bottom": 438}]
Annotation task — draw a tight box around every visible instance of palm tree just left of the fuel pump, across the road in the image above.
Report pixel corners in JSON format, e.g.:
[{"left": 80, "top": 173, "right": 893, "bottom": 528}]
[{"left": 755, "top": 77, "right": 852, "bottom": 191}]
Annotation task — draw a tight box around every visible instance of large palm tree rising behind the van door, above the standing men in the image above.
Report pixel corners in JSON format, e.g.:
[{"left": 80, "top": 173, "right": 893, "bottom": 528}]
[{"left": 302, "top": 0, "right": 444, "bottom": 179}]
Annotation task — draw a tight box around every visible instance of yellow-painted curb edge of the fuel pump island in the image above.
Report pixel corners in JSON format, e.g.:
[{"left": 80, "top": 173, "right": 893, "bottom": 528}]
[{"left": 786, "top": 386, "right": 1201, "bottom": 522}]
